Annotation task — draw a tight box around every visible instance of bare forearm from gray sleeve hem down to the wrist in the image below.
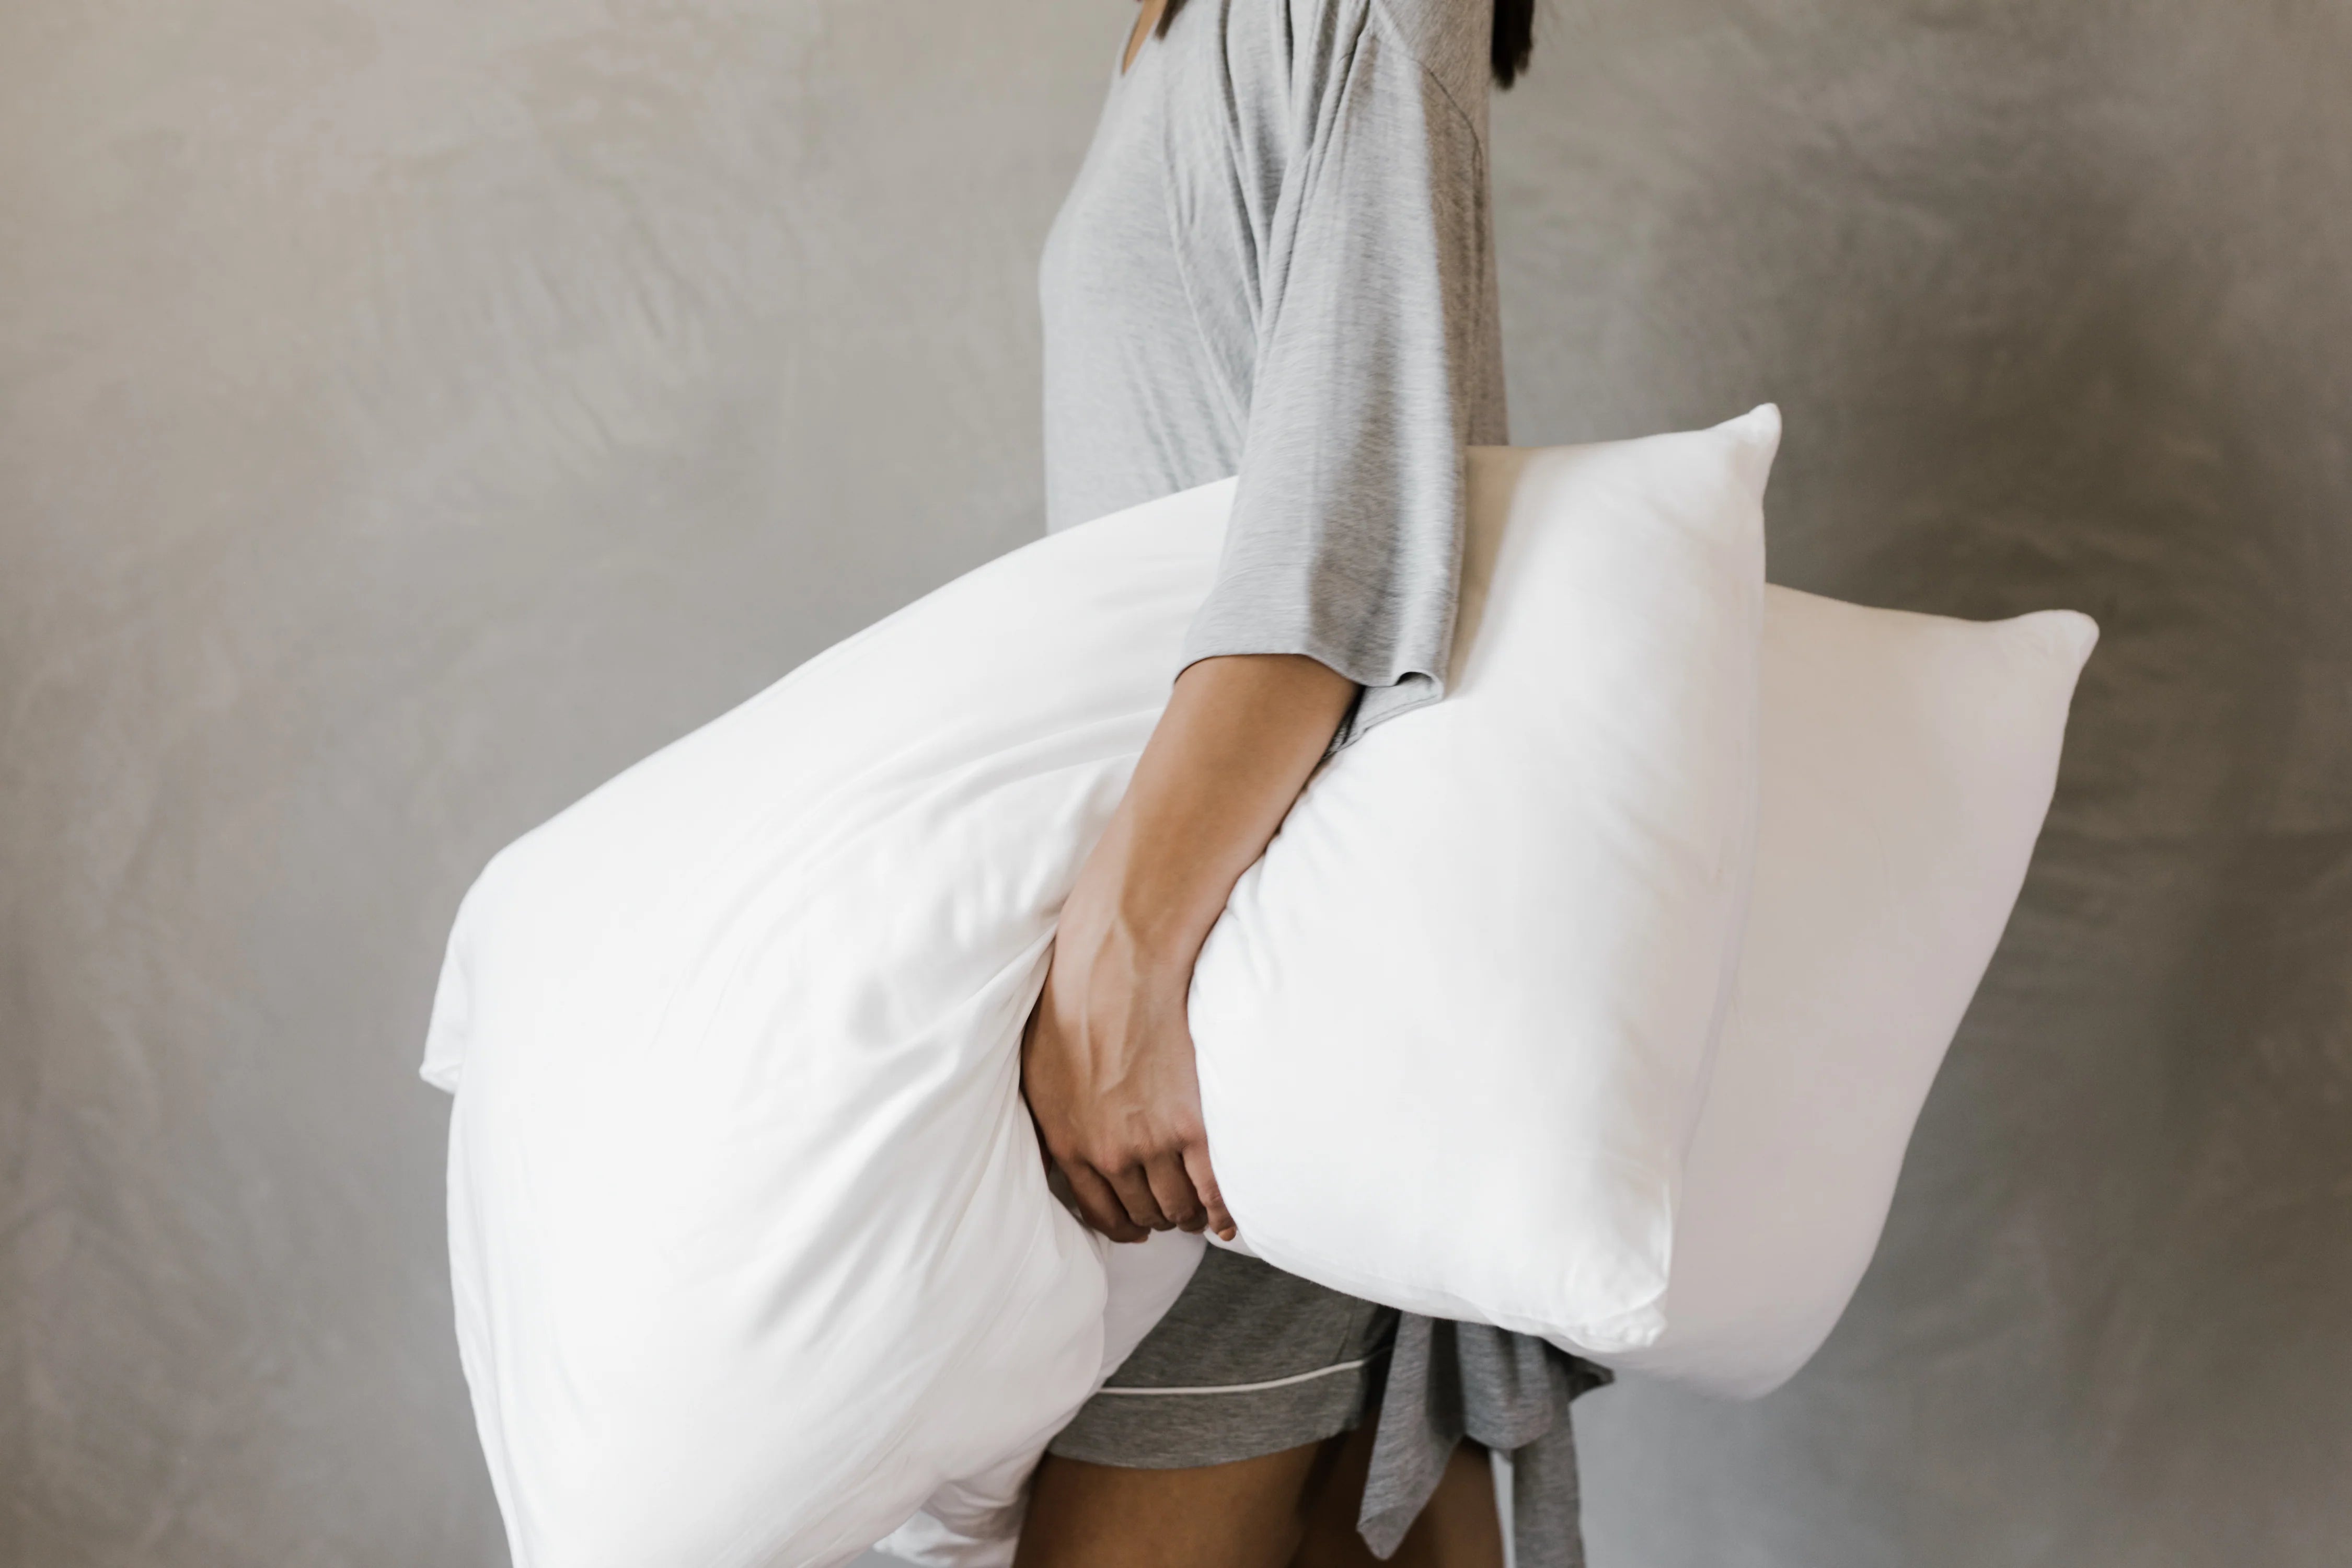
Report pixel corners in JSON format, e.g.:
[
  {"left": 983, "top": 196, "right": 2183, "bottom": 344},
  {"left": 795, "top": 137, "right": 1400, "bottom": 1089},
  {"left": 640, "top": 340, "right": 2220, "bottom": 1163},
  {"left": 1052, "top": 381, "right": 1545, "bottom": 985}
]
[{"left": 1073, "top": 653, "right": 1355, "bottom": 976}]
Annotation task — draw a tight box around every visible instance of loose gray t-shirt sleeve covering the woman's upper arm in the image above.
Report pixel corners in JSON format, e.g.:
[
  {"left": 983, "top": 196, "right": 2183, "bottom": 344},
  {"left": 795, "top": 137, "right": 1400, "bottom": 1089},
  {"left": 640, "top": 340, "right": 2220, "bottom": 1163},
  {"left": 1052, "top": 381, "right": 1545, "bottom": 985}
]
[{"left": 1183, "top": 9, "right": 1501, "bottom": 750}]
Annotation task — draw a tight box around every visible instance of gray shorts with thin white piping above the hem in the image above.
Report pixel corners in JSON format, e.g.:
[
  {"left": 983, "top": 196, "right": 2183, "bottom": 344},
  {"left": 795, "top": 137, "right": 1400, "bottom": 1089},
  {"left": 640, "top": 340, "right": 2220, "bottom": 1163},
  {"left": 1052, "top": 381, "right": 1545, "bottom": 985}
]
[{"left": 1047, "top": 1246, "right": 1397, "bottom": 1469}]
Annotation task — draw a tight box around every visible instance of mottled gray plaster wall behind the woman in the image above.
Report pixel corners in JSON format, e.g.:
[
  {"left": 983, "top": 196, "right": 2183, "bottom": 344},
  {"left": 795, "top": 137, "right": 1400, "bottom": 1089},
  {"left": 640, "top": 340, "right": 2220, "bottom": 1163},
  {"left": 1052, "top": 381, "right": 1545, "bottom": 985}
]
[{"left": 0, "top": 0, "right": 2352, "bottom": 1568}]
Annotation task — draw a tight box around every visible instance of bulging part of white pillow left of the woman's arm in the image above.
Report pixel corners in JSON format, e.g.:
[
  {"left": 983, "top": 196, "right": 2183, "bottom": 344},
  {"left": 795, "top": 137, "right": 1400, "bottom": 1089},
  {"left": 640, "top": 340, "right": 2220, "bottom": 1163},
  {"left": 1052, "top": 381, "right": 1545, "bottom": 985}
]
[{"left": 426, "top": 487, "right": 1230, "bottom": 1568}]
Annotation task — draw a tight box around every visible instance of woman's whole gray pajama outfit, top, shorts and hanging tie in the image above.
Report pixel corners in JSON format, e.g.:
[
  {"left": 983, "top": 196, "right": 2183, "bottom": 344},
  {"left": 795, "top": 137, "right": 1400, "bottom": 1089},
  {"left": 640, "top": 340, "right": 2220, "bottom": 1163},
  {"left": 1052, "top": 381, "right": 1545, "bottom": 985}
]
[{"left": 1040, "top": 0, "right": 1607, "bottom": 1568}]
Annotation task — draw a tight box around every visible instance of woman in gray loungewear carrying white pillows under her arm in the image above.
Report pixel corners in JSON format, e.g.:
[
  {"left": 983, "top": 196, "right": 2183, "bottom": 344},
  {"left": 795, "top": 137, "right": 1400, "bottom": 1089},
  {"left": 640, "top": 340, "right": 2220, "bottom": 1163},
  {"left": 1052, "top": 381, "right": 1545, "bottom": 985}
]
[{"left": 1021, "top": 0, "right": 1597, "bottom": 1568}]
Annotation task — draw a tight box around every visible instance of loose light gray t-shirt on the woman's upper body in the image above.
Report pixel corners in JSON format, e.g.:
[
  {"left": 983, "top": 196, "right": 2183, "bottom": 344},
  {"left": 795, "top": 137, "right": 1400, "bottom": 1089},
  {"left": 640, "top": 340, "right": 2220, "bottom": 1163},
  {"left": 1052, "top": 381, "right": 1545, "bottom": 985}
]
[{"left": 1040, "top": 0, "right": 1510, "bottom": 750}]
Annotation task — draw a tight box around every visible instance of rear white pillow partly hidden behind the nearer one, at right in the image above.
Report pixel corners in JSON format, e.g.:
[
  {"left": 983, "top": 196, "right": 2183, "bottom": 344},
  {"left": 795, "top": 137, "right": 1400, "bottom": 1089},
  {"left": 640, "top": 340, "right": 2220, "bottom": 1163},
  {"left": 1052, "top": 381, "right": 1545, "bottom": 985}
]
[{"left": 1599, "top": 587, "right": 2098, "bottom": 1399}]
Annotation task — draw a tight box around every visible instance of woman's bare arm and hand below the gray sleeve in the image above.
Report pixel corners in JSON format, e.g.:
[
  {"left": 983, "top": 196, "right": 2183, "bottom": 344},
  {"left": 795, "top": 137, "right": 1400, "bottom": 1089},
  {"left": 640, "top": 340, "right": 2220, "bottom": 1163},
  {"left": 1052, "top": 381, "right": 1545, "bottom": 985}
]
[{"left": 1021, "top": 653, "right": 1355, "bottom": 1241}]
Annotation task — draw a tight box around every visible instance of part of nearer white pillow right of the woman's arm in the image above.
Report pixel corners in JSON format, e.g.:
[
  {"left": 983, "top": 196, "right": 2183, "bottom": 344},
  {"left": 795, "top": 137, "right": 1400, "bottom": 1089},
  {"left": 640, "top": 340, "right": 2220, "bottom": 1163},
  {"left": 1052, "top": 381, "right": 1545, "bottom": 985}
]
[{"left": 1190, "top": 407, "right": 1781, "bottom": 1350}]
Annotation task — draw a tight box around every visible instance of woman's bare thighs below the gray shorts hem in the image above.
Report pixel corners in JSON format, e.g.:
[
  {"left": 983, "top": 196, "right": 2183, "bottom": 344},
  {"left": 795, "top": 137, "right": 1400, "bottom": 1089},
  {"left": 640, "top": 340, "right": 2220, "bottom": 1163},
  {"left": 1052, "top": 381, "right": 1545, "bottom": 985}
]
[{"left": 1014, "top": 1417, "right": 1503, "bottom": 1568}]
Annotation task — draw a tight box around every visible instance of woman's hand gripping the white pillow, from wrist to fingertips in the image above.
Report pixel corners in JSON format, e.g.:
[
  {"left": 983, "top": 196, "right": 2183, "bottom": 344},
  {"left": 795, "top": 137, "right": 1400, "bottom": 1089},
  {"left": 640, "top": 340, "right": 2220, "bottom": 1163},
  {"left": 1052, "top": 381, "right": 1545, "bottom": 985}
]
[{"left": 1021, "top": 863, "right": 1235, "bottom": 1241}]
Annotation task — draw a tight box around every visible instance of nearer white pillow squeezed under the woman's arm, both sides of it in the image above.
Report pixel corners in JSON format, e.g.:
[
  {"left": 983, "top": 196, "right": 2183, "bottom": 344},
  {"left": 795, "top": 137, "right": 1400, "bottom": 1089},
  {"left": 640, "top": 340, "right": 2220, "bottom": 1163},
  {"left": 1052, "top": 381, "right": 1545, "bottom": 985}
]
[{"left": 426, "top": 409, "right": 1778, "bottom": 1568}]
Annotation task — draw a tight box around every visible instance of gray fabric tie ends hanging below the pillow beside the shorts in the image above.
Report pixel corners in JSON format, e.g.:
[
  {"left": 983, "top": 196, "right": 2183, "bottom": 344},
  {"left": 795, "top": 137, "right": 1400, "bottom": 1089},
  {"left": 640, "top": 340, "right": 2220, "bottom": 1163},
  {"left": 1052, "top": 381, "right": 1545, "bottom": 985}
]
[{"left": 1357, "top": 1314, "right": 1611, "bottom": 1568}]
